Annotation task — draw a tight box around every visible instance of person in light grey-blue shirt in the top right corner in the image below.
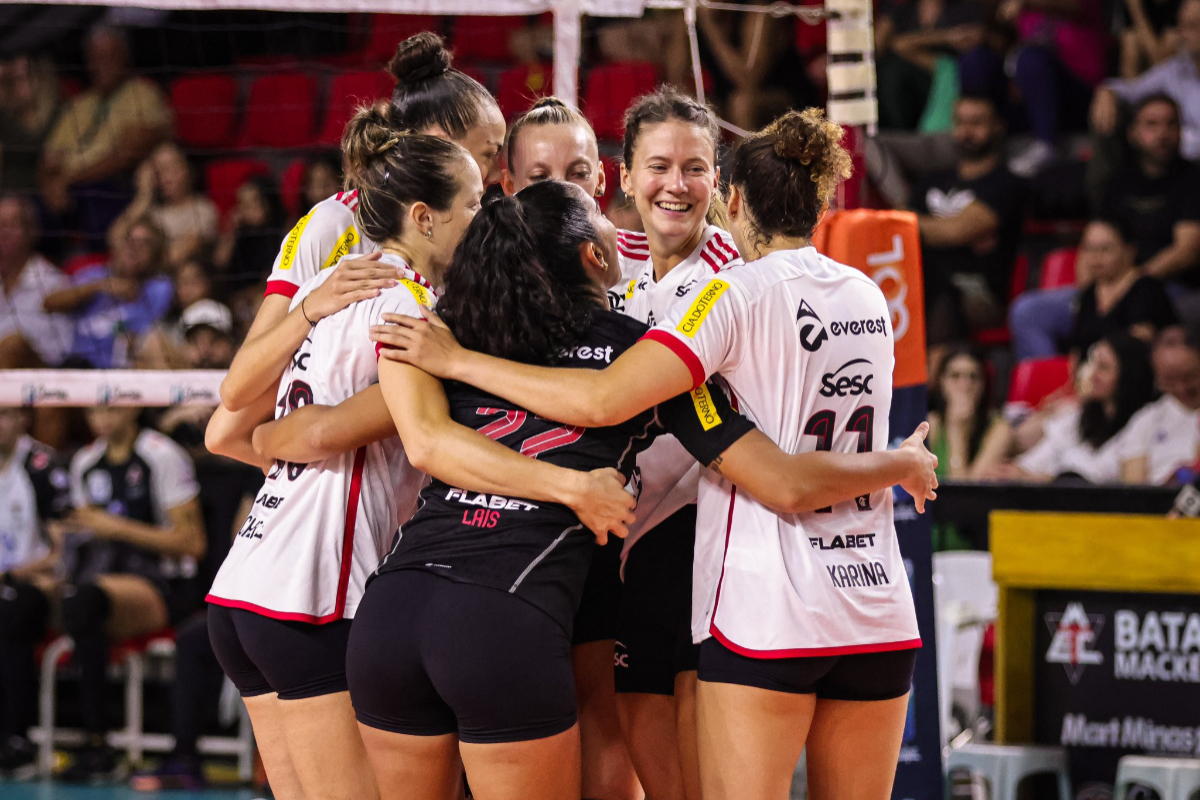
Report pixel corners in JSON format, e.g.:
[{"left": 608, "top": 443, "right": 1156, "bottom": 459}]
[{"left": 1092, "top": 0, "right": 1200, "bottom": 161}]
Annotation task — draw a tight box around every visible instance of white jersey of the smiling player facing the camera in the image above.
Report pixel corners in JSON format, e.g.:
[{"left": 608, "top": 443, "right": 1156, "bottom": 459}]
[{"left": 608, "top": 225, "right": 742, "bottom": 557}]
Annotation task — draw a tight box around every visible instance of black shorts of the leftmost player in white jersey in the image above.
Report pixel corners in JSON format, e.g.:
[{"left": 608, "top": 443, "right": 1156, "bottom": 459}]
[{"left": 209, "top": 604, "right": 352, "bottom": 700}]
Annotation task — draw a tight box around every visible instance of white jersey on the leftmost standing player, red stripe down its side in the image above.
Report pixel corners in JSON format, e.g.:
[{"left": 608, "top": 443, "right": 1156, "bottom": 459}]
[{"left": 208, "top": 254, "right": 434, "bottom": 624}]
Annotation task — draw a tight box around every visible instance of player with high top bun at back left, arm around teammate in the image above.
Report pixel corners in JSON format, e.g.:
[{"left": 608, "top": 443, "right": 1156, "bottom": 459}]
[{"left": 205, "top": 31, "right": 504, "bottom": 463}]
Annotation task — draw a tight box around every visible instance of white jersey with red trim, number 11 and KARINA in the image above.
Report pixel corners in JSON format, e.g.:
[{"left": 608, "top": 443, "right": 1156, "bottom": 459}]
[{"left": 646, "top": 247, "right": 920, "bottom": 657}]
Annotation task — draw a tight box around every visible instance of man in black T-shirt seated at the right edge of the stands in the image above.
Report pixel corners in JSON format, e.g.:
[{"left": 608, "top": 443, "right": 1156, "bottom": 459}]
[{"left": 1103, "top": 94, "right": 1200, "bottom": 307}]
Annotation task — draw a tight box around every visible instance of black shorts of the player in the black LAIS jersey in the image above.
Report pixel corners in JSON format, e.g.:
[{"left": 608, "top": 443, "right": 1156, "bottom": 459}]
[{"left": 346, "top": 570, "right": 576, "bottom": 744}]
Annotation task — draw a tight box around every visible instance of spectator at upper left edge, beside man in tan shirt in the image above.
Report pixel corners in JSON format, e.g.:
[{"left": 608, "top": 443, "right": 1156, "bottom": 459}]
[{"left": 0, "top": 55, "right": 60, "bottom": 192}]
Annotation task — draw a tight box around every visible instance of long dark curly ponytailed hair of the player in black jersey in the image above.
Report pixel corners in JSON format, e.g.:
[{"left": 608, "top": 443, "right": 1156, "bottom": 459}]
[{"left": 438, "top": 181, "right": 602, "bottom": 365}]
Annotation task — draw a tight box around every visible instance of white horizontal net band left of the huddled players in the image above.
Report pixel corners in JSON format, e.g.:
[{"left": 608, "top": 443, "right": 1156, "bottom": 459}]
[{"left": 0, "top": 369, "right": 226, "bottom": 407}]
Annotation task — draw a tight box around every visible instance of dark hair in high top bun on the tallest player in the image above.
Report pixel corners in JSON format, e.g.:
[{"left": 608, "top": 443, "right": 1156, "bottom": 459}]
[{"left": 388, "top": 31, "right": 499, "bottom": 140}]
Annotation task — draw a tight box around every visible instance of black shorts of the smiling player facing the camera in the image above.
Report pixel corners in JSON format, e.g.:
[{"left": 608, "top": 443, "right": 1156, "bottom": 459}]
[{"left": 613, "top": 505, "right": 700, "bottom": 696}]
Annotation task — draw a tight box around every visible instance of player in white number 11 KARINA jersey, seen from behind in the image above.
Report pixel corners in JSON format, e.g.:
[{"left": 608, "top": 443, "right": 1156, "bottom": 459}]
[{"left": 374, "top": 109, "right": 936, "bottom": 800}]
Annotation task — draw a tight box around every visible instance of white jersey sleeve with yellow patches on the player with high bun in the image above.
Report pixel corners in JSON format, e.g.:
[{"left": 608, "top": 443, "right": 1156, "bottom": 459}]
[{"left": 266, "top": 191, "right": 379, "bottom": 297}]
